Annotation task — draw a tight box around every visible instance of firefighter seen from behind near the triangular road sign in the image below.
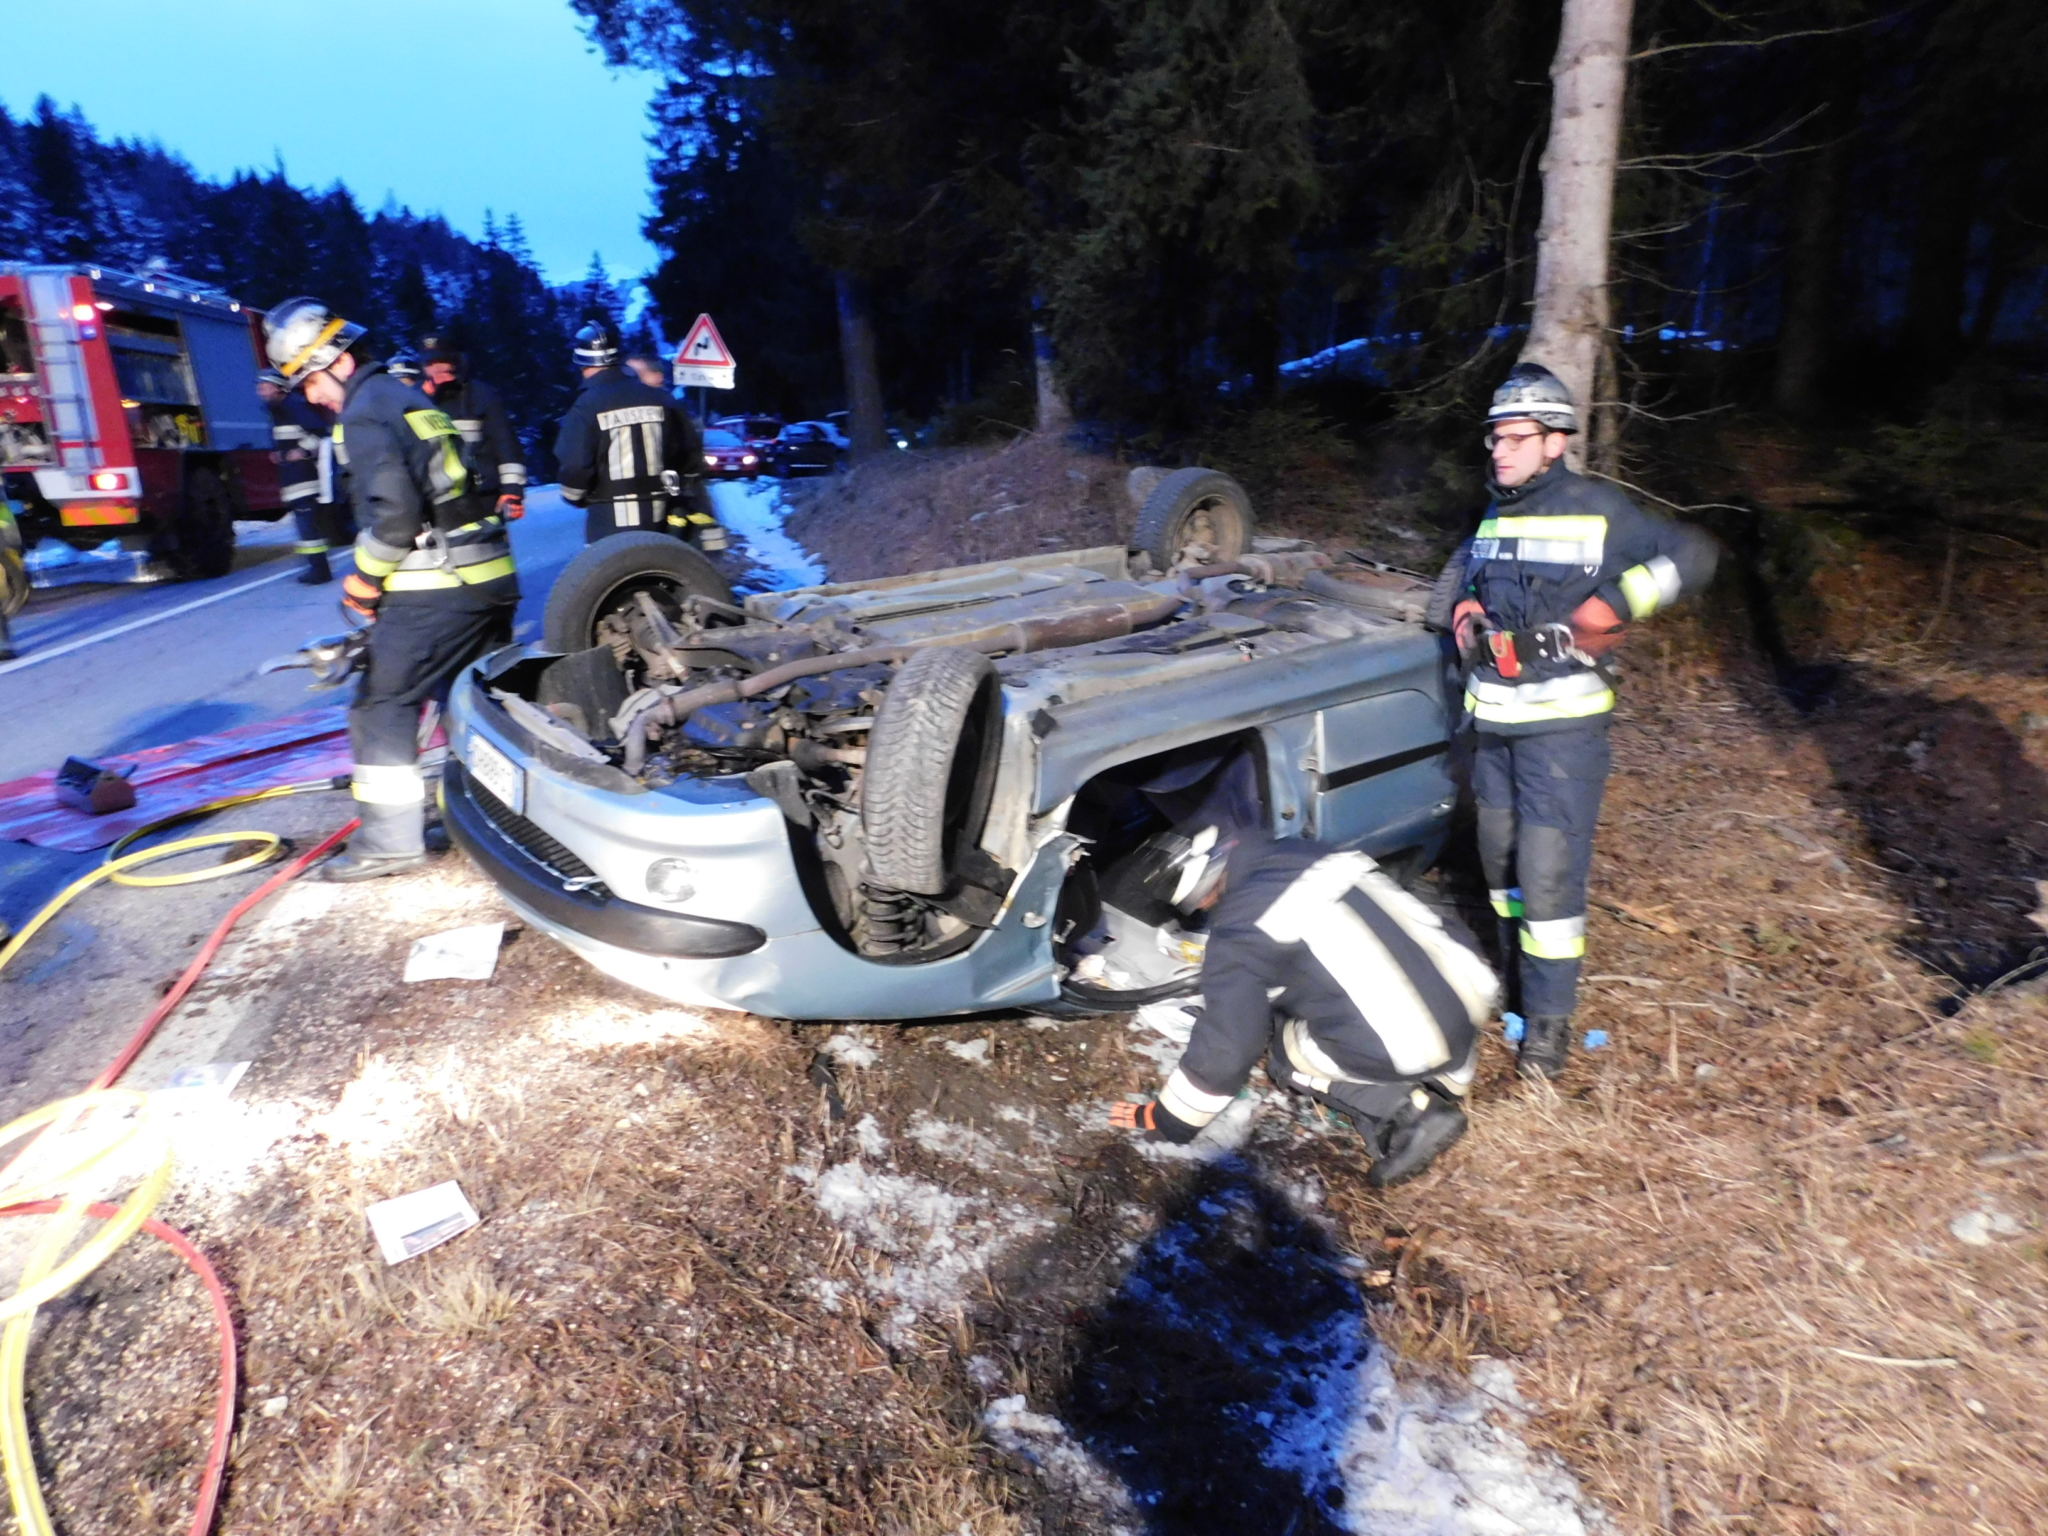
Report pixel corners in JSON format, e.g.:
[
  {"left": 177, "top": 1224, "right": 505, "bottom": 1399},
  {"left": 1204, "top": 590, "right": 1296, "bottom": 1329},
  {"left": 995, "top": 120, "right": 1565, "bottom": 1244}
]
[{"left": 555, "top": 319, "right": 725, "bottom": 553}]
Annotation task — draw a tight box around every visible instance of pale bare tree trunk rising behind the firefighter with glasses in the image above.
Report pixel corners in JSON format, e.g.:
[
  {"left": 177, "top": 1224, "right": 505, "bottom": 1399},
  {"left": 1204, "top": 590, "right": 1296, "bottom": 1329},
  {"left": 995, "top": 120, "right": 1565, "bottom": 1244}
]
[{"left": 1522, "top": 0, "right": 1634, "bottom": 469}]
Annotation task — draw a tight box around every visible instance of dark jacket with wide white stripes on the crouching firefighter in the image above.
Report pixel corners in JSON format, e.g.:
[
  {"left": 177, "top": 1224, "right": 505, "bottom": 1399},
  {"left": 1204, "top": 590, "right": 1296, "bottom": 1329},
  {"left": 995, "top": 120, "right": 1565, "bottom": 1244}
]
[{"left": 1159, "top": 840, "right": 1499, "bottom": 1141}]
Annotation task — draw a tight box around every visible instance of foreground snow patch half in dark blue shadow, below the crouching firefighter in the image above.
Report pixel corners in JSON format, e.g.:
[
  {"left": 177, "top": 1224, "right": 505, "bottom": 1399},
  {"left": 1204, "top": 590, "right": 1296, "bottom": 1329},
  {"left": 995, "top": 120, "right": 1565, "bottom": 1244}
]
[{"left": 983, "top": 1159, "right": 1606, "bottom": 1536}]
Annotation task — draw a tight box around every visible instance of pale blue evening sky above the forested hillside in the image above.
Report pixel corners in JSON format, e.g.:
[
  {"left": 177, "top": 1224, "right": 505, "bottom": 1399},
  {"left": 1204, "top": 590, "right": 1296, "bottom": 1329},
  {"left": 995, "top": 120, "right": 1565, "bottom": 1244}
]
[{"left": 0, "top": 0, "right": 655, "bottom": 283}]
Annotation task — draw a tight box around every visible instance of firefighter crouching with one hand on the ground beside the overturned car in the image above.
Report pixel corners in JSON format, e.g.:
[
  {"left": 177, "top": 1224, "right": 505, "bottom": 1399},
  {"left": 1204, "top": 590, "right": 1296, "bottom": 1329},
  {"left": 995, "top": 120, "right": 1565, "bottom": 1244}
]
[{"left": 1110, "top": 827, "right": 1499, "bottom": 1188}]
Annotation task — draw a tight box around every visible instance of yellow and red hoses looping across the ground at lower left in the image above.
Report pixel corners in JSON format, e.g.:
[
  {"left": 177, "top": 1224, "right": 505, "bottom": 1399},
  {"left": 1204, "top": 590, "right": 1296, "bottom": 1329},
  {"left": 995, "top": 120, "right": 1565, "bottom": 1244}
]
[{"left": 0, "top": 794, "right": 358, "bottom": 1536}]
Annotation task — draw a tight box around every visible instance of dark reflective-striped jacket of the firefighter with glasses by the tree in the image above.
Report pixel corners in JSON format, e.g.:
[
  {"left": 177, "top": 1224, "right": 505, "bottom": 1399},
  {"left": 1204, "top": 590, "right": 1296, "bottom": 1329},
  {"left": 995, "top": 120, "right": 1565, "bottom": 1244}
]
[{"left": 1460, "top": 461, "right": 1714, "bottom": 735}]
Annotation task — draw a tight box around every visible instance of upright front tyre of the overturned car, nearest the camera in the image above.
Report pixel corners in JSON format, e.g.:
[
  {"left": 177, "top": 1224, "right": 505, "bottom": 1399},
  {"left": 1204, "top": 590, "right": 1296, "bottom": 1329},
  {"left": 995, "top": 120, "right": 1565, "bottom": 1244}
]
[{"left": 860, "top": 645, "right": 1004, "bottom": 895}]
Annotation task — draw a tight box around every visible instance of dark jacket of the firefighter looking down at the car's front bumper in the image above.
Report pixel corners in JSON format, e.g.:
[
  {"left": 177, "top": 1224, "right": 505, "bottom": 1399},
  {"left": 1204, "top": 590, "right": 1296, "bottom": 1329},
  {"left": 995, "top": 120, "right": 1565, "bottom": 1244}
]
[{"left": 334, "top": 362, "right": 518, "bottom": 600}]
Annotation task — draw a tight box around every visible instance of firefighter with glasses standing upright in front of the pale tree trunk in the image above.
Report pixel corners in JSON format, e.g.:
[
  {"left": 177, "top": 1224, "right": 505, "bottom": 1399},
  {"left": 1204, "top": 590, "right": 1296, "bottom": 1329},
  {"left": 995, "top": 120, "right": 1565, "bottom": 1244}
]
[{"left": 1440, "top": 362, "right": 1716, "bottom": 1077}]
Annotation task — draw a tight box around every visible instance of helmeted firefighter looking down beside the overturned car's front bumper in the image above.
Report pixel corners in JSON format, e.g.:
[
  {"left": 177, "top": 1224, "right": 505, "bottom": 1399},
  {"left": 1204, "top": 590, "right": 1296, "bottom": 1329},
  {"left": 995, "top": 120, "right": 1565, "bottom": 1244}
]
[{"left": 264, "top": 299, "right": 518, "bottom": 881}]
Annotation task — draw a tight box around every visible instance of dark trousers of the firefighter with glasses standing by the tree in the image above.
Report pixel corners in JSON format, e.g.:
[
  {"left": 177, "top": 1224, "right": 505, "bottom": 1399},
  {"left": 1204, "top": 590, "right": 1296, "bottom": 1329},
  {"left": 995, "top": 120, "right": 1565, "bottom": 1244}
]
[{"left": 1473, "top": 717, "right": 1612, "bottom": 1018}]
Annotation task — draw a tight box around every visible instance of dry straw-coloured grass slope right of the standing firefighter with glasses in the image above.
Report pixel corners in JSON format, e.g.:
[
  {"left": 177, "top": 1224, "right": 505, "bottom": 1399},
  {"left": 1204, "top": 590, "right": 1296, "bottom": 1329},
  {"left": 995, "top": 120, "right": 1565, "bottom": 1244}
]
[{"left": 1339, "top": 507, "right": 2048, "bottom": 1536}]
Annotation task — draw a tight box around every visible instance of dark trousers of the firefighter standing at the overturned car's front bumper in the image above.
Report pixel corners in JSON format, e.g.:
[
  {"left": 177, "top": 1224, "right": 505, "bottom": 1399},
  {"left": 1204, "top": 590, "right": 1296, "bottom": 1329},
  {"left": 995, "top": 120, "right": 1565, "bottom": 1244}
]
[{"left": 348, "top": 592, "right": 514, "bottom": 858}]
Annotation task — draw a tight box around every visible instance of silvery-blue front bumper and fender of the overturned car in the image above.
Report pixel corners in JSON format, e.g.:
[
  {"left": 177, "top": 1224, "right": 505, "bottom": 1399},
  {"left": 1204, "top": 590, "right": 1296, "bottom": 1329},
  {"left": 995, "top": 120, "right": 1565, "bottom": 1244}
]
[{"left": 444, "top": 647, "right": 1075, "bottom": 1020}]
